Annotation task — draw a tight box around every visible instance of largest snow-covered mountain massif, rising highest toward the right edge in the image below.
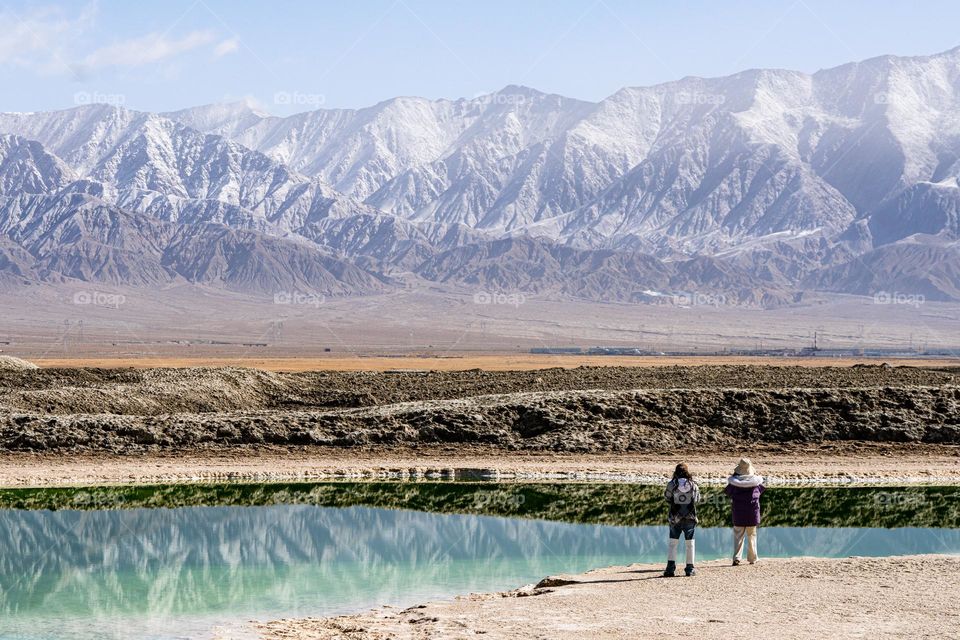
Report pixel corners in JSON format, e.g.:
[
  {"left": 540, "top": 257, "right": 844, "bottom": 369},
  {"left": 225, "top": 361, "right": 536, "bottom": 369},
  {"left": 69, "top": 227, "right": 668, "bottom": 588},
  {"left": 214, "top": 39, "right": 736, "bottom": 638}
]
[{"left": 172, "top": 49, "right": 960, "bottom": 253}]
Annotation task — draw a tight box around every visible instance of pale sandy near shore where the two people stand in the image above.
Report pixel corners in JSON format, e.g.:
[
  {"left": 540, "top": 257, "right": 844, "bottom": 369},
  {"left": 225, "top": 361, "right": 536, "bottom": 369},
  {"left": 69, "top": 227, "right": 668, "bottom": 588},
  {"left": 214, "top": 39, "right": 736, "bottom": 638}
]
[{"left": 257, "top": 555, "right": 960, "bottom": 640}]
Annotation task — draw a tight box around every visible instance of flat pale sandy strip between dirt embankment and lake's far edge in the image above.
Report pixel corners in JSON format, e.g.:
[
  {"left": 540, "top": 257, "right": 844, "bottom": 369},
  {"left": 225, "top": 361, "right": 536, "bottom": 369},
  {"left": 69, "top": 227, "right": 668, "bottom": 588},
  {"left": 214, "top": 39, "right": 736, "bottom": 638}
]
[{"left": 0, "top": 445, "right": 960, "bottom": 487}]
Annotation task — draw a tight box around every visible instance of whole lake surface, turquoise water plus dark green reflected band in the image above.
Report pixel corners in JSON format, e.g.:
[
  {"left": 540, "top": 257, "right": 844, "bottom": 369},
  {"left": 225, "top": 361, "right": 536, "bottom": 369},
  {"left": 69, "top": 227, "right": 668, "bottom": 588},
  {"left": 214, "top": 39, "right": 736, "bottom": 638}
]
[{"left": 0, "top": 482, "right": 960, "bottom": 640}]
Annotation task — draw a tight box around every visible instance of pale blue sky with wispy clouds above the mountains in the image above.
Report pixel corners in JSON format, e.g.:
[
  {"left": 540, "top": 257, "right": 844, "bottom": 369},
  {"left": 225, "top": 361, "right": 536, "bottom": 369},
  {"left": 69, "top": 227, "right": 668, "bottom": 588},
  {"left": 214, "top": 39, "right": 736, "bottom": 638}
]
[{"left": 0, "top": 0, "right": 960, "bottom": 115}]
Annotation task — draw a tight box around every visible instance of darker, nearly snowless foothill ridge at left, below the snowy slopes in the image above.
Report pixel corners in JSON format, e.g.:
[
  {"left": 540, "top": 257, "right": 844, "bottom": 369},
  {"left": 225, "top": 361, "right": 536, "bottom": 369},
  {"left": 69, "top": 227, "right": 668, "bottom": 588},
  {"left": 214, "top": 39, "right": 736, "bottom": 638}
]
[{"left": 0, "top": 135, "right": 394, "bottom": 295}]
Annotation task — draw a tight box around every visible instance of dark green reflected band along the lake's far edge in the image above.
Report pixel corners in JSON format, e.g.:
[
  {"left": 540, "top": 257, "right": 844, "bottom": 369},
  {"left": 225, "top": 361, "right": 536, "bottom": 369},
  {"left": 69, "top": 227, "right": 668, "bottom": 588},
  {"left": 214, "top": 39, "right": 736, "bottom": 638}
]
[{"left": 0, "top": 482, "right": 960, "bottom": 528}]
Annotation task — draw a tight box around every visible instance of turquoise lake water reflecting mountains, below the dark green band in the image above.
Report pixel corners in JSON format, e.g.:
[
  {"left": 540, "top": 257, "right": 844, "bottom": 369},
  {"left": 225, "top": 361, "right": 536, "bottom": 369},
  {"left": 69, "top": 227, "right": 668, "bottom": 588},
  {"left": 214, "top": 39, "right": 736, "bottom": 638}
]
[{"left": 0, "top": 485, "right": 960, "bottom": 640}]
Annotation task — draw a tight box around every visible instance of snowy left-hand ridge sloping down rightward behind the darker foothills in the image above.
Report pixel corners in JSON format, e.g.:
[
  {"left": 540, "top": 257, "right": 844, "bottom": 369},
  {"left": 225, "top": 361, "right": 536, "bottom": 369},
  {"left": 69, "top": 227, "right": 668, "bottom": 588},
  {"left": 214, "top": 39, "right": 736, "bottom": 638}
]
[{"left": 0, "top": 105, "right": 378, "bottom": 232}]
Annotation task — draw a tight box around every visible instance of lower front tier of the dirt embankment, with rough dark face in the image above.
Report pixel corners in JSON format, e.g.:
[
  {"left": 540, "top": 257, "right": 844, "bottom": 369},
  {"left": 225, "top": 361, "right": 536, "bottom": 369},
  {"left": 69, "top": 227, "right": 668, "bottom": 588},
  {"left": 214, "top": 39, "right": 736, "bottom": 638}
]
[{"left": 0, "top": 386, "right": 960, "bottom": 453}]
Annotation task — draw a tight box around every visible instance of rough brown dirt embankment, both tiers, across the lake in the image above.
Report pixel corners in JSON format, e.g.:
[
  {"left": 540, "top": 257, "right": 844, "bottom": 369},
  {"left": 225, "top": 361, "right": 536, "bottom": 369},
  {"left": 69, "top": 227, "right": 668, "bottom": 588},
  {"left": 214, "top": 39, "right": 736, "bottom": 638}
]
[{"left": 0, "top": 366, "right": 960, "bottom": 453}]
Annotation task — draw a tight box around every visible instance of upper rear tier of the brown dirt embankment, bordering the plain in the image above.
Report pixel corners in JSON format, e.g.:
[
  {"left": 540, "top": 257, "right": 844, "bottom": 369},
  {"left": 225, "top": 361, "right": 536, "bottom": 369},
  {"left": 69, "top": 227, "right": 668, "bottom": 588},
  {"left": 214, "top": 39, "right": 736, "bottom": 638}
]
[{"left": 0, "top": 365, "right": 960, "bottom": 415}]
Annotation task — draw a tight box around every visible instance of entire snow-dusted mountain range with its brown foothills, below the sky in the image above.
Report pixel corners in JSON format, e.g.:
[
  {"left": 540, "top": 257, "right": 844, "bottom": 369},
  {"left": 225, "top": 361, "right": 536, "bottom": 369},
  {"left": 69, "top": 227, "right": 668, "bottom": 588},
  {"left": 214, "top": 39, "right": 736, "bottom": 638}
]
[{"left": 0, "top": 48, "right": 960, "bottom": 304}]
